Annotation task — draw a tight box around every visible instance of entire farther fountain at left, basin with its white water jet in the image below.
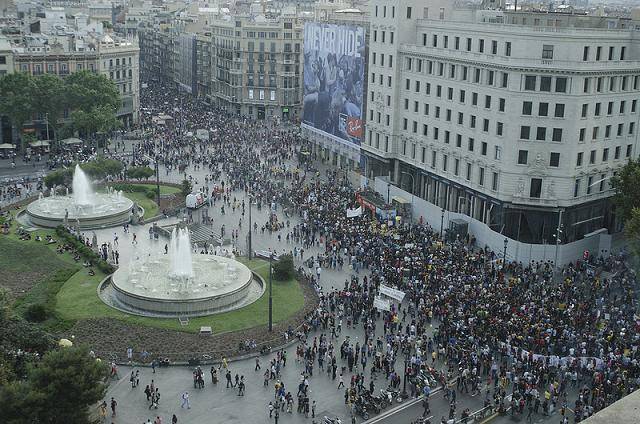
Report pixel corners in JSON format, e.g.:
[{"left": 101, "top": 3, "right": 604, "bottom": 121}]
[{"left": 27, "top": 165, "right": 133, "bottom": 230}]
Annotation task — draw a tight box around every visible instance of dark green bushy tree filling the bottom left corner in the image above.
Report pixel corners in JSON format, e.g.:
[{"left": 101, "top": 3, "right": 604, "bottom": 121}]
[{"left": 0, "top": 347, "right": 107, "bottom": 424}]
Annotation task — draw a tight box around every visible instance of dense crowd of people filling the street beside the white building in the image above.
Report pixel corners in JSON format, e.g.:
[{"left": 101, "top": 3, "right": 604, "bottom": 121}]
[{"left": 126, "top": 83, "right": 640, "bottom": 422}]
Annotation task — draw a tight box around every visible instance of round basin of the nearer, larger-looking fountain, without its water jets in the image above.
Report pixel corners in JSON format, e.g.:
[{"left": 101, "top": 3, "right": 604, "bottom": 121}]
[{"left": 109, "top": 255, "right": 264, "bottom": 317}]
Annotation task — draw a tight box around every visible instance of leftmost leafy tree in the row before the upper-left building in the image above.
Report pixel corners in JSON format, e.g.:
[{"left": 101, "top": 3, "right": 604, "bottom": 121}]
[{"left": 0, "top": 72, "right": 38, "bottom": 151}]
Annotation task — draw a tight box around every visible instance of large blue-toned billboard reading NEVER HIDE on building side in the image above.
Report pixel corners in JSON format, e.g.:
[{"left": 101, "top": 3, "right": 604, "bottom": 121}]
[{"left": 302, "top": 22, "right": 365, "bottom": 145}]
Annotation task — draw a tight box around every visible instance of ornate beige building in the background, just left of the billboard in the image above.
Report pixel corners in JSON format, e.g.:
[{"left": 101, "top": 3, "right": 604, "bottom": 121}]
[{"left": 206, "top": 16, "right": 303, "bottom": 120}]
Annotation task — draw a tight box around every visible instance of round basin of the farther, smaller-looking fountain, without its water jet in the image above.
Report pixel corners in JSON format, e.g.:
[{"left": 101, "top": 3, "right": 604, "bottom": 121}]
[{"left": 27, "top": 193, "right": 133, "bottom": 230}]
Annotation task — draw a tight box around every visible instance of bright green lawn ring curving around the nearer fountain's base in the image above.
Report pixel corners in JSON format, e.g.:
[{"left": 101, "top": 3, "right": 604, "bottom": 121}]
[{"left": 56, "top": 260, "right": 304, "bottom": 334}]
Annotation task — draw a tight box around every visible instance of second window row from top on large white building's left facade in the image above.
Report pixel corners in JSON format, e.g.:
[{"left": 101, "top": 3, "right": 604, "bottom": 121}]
[{"left": 404, "top": 57, "right": 509, "bottom": 88}]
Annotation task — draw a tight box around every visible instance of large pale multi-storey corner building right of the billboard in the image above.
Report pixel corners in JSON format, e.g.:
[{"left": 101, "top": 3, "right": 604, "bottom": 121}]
[{"left": 362, "top": 0, "right": 640, "bottom": 249}]
